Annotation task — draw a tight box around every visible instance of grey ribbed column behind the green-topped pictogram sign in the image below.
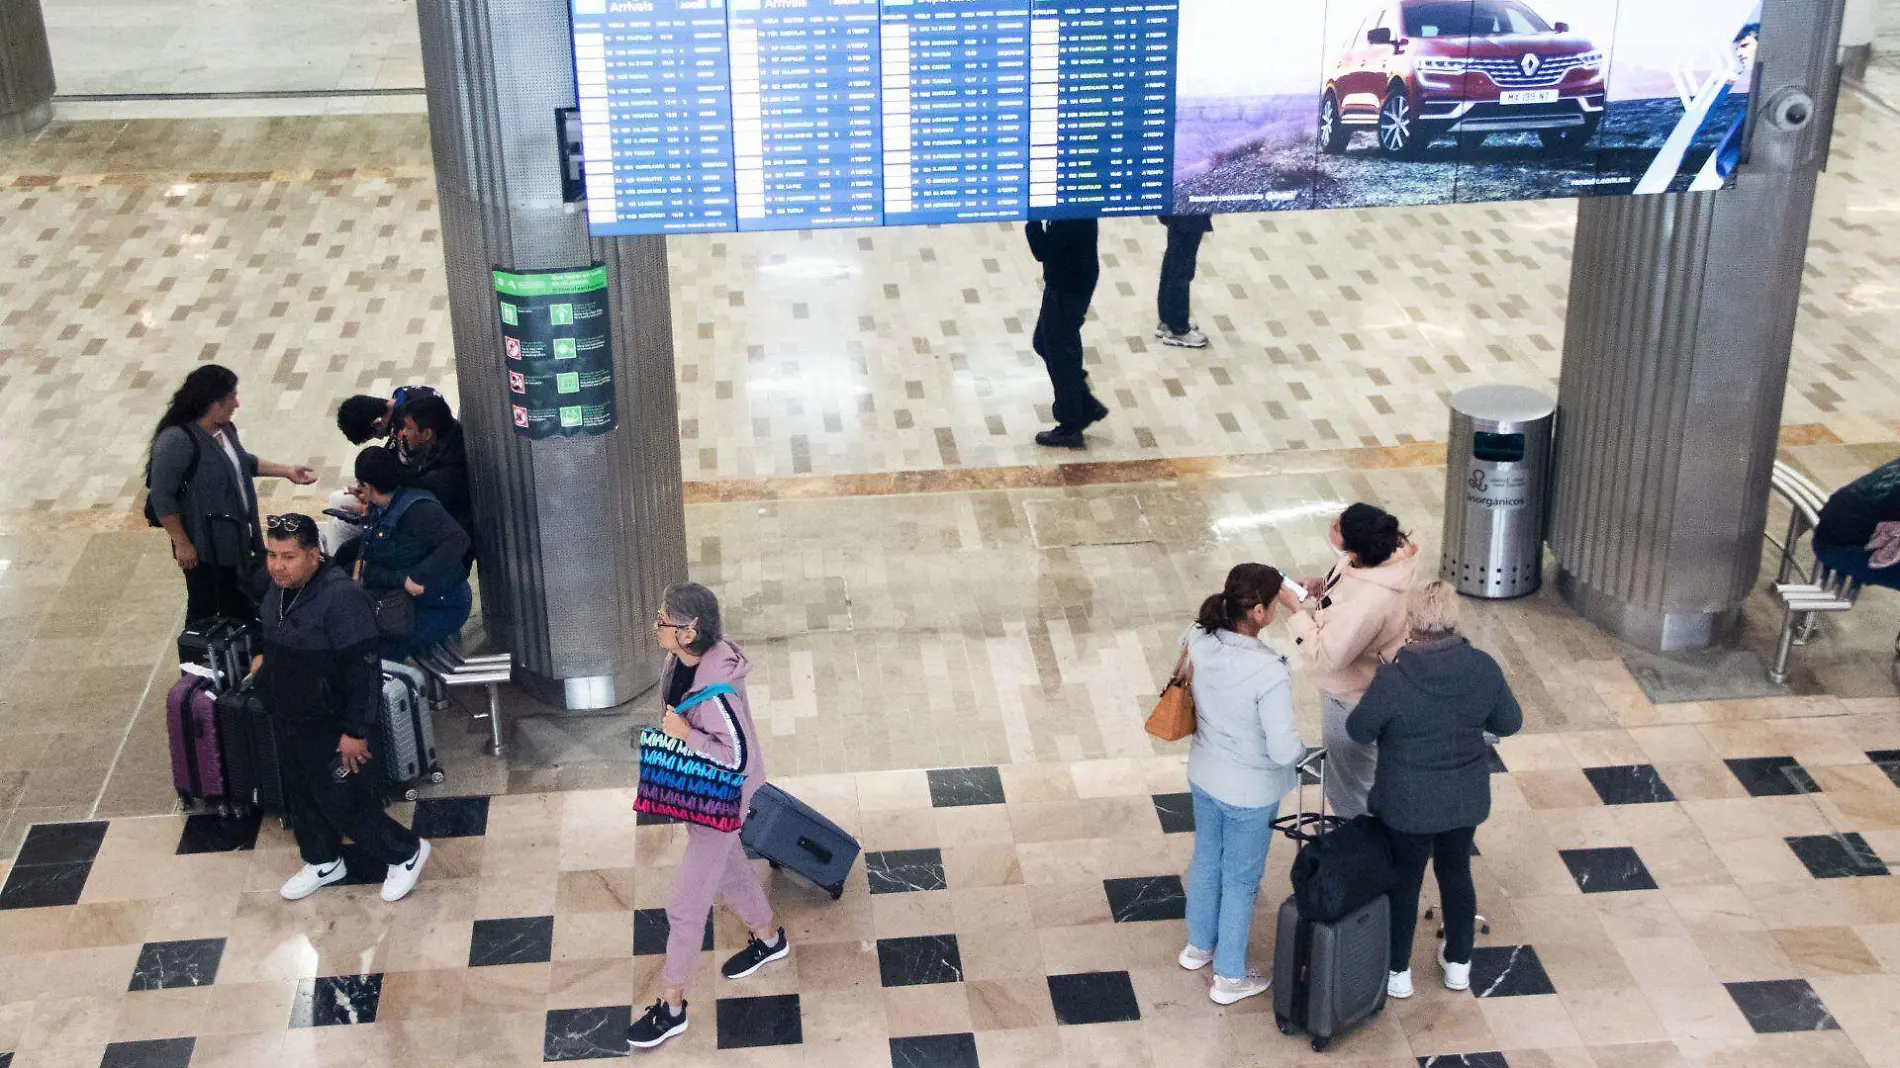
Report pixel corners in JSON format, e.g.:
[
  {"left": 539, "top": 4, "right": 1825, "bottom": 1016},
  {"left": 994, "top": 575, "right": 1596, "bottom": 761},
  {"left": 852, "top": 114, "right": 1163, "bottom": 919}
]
[{"left": 416, "top": 0, "right": 686, "bottom": 709}]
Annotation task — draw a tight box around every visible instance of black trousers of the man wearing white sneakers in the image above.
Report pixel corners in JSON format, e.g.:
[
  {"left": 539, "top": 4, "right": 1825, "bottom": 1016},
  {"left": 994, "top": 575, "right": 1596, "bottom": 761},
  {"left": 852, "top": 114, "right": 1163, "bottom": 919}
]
[{"left": 277, "top": 724, "right": 420, "bottom": 865}]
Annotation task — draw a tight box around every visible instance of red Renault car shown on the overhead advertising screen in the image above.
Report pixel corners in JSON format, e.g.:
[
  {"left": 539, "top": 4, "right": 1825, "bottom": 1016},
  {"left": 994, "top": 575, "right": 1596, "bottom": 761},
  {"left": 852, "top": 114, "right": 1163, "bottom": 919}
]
[{"left": 1319, "top": 0, "right": 1609, "bottom": 156}]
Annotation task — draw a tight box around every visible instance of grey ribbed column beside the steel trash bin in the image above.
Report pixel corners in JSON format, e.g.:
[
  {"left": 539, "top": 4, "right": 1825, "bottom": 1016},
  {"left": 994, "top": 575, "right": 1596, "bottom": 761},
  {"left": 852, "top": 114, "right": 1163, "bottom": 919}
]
[{"left": 1550, "top": 0, "right": 1841, "bottom": 652}]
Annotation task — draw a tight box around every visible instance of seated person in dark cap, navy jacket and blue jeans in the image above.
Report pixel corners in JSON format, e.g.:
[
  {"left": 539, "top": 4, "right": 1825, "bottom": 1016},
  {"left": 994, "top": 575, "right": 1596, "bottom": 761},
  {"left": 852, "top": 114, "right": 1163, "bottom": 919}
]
[{"left": 355, "top": 445, "right": 475, "bottom": 661}]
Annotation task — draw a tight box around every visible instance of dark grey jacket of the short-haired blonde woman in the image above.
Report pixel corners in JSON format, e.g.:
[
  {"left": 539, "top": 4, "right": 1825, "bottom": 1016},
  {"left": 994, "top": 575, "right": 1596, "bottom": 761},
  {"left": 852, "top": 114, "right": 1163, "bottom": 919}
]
[{"left": 1345, "top": 637, "right": 1524, "bottom": 834}]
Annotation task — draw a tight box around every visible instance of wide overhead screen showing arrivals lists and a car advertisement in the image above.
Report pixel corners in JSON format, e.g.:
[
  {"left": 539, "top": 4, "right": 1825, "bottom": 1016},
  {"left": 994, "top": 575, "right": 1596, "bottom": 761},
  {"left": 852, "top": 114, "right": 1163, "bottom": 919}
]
[{"left": 572, "top": 0, "right": 1761, "bottom": 236}]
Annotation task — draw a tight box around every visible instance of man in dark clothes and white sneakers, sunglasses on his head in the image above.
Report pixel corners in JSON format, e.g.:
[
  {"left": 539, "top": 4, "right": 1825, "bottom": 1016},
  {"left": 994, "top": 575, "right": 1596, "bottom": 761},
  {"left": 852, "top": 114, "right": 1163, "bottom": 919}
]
[{"left": 257, "top": 515, "right": 429, "bottom": 901}]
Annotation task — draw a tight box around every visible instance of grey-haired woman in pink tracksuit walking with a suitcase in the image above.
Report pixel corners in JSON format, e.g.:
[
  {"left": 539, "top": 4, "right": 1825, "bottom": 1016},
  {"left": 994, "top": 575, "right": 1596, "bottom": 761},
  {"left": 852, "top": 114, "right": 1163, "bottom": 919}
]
[{"left": 627, "top": 582, "right": 792, "bottom": 1049}]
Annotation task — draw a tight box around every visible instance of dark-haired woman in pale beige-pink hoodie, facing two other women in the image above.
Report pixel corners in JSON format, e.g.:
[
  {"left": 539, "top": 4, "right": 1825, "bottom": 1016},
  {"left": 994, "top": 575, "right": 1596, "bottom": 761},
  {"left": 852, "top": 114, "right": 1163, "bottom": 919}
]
[{"left": 1286, "top": 504, "right": 1419, "bottom": 817}]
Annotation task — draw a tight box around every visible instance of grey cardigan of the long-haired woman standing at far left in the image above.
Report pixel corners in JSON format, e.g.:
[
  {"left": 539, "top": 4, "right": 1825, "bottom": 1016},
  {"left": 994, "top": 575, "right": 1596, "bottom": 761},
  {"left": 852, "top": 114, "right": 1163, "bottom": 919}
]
[{"left": 152, "top": 422, "right": 264, "bottom": 572}]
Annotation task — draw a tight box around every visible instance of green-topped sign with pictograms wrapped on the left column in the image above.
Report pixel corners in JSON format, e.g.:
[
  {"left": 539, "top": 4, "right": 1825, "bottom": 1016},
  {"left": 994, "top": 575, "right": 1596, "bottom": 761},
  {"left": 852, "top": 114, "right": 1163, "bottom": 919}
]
[{"left": 494, "top": 264, "right": 614, "bottom": 439}]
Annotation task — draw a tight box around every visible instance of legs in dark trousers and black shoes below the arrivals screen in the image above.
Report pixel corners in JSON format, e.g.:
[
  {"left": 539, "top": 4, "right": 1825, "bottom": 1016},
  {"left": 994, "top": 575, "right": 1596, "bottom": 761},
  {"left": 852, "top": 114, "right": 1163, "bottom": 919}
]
[{"left": 1024, "top": 219, "right": 1108, "bottom": 448}]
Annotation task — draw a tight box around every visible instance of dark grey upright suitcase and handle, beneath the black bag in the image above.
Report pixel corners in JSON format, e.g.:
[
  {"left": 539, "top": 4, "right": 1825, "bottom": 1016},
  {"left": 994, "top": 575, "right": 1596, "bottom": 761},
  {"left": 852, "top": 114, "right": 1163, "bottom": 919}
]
[{"left": 1273, "top": 749, "right": 1393, "bottom": 1053}]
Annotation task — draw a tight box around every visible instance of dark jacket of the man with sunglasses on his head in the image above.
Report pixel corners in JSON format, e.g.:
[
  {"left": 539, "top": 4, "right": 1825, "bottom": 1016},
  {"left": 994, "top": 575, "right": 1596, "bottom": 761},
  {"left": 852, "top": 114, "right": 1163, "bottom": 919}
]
[{"left": 257, "top": 564, "right": 382, "bottom": 737}]
